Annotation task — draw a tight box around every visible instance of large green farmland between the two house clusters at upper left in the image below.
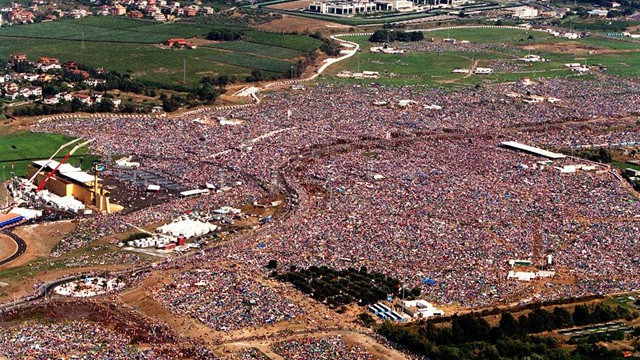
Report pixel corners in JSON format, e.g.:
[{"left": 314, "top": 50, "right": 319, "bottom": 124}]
[{"left": 0, "top": 17, "right": 321, "bottom": 85}]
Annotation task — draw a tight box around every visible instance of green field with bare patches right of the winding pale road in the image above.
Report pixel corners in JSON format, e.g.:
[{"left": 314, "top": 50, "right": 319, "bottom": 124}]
[{"left": 325, "top": 28, "right": 640, "bottom": 87}]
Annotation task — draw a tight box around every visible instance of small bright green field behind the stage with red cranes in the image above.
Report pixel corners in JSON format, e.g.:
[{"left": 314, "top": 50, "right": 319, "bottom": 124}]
[{"left": 0, "top": 132, "right": 96, "bottom": 180}]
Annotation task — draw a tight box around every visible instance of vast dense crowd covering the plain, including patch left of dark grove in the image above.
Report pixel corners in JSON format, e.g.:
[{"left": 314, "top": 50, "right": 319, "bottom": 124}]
[{"left": 23, "top": 77, "right": 640, "bottom": 310}]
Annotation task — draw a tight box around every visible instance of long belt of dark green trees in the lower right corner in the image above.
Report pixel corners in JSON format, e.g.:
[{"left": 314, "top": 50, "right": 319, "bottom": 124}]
[{"left": 377, "top": 304, "right": 638, "bottom": 359}]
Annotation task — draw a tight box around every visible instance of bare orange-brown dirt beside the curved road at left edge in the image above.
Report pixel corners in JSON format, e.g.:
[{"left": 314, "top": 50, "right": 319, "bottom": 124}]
[{"left": 0, "top": 220, "right": 76, "bottom": 270}]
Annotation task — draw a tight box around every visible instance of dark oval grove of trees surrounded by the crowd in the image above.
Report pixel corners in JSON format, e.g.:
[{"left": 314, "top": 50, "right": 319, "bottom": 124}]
[{"left": 272, "top": 266, "right": 400, "bottom": 306}]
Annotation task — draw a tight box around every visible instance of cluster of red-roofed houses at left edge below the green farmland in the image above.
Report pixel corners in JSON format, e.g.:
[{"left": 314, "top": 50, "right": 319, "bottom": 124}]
[{"left": 0, "top": 54, "right": 121, "bottom": 107}]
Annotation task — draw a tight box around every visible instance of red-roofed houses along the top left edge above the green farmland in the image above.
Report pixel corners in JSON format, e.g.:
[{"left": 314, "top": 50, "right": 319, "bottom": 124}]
[{"left": 0, "top": 0, "right": 214, "bottom": 26}]
